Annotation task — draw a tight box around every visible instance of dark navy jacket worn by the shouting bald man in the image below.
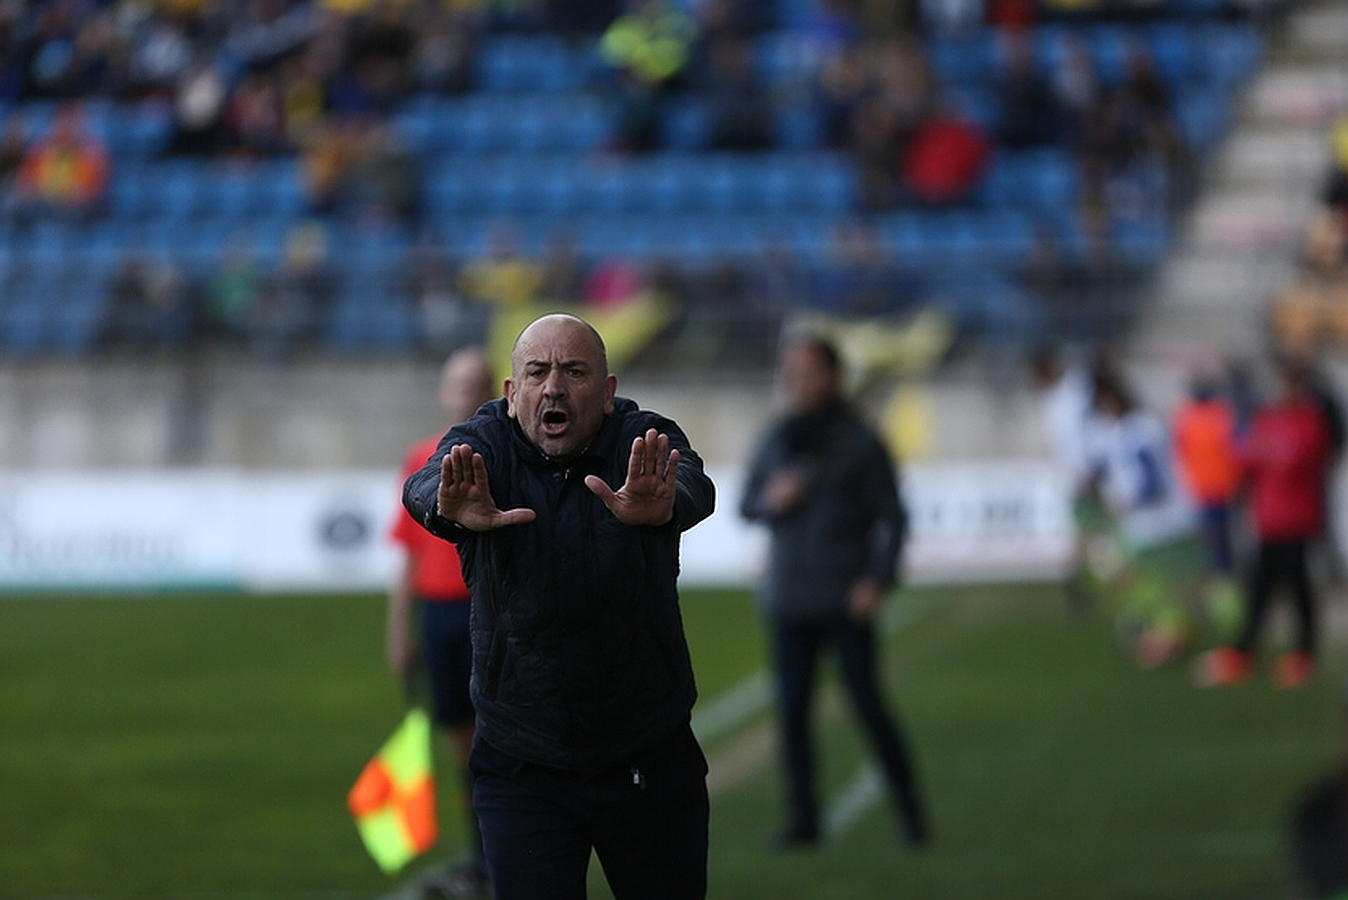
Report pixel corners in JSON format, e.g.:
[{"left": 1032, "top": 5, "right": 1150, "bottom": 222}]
[{"left": 403, "top": 397, "right": 716, "bottom": 775}]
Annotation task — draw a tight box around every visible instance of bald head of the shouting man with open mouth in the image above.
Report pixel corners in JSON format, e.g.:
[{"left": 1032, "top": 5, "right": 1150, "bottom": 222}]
[{"left": 506, "top": 313, "right": 617, "bottom": 458}]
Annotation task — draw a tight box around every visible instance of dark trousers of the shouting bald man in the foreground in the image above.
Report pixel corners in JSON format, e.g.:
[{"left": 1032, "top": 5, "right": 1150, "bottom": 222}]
[{"left": 470, "top": 726, "right": 709, "bottom": 900}]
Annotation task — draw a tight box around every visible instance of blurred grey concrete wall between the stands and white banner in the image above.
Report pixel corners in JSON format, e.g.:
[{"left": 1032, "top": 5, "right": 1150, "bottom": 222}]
[{"left": 0, "top": 356, "right": 1073, "bottom": 469}]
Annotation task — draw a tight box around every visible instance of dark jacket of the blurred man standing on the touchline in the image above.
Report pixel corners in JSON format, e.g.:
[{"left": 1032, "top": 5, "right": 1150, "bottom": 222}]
[{"left": 740, "top": 400, "right": 909, "bottom": 622}]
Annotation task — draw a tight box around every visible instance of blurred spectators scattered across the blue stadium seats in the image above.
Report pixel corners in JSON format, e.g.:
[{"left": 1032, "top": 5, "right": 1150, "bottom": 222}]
[{"left": 0, "top": 0, "right": 1261, "bottom": 353}]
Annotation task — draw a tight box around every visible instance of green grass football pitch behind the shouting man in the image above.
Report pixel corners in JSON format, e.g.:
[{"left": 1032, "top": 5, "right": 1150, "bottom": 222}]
[{"left": 0, "top": 586, "right": 1348, "bottom": 900}]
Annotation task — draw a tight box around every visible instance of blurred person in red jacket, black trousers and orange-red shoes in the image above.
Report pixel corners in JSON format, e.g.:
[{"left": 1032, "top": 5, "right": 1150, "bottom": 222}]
[{"left": 1198, "top": 364, "right": 1330, "bottom": 687}]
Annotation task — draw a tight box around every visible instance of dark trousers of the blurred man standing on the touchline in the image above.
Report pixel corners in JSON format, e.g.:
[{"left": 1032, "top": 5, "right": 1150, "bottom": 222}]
[{"left": 772, "top": 616, "right": 926, "bottom": 841}]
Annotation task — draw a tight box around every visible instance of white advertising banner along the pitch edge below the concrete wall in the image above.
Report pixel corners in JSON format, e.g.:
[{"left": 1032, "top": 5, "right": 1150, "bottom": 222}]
[{"left": 0, "top": 462, "right": 1070, "bottom": 590}]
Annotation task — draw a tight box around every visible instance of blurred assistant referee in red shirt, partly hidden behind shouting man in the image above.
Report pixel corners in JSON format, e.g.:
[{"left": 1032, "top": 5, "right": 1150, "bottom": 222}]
[{"left": 386, "top": 348, "right": 495, "bottom": 897}]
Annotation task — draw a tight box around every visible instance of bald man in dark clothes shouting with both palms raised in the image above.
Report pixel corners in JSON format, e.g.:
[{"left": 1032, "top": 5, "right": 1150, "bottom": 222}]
[{"left": 403, "top": 315, "right": 714, "bottom": 900}]
